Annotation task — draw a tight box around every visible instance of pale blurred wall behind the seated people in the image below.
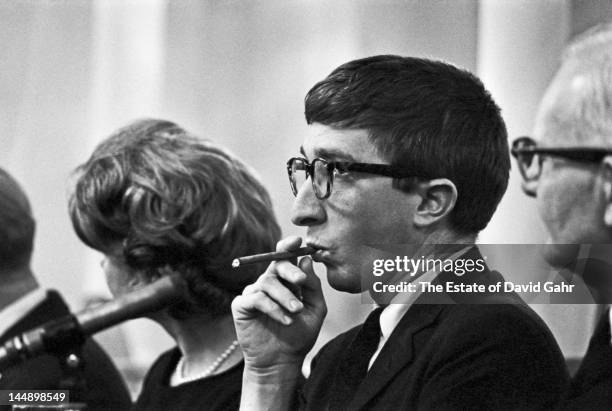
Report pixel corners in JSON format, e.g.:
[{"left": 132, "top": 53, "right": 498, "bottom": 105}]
[{"left": 0, "top": 0, "right": 612, "bottom": 398}]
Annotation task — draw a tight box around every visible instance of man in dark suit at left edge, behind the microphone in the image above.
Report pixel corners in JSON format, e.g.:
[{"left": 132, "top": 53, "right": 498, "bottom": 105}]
[{"left": 0, "top": 169, "right": 131, "bottom": 410}]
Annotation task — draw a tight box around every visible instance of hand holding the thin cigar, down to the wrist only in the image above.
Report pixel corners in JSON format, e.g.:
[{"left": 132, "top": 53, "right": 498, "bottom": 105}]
[{"left": 232, "top": 237, "right": 327, "bottom": 376}]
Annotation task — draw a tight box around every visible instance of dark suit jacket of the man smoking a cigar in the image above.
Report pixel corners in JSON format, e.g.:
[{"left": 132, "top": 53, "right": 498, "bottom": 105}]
[{"left": 300, "top": 251, "right": 569, "bottom": 410}]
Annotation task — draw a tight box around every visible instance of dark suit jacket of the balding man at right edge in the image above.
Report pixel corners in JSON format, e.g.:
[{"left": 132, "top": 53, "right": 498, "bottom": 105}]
[{"left": 561, "top": 311, "right": 612, "bottom": 410}]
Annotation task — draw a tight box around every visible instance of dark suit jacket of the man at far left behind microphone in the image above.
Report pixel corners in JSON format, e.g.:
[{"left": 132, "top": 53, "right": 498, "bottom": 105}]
[{"left": 0, "top": 291, "right": 131, "bottom": 410}]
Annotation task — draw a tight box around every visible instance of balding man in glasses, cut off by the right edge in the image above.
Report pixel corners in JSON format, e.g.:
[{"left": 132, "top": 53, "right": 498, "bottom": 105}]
[{"left": 513, "top": 25, "right": 612, "bottom": 410}]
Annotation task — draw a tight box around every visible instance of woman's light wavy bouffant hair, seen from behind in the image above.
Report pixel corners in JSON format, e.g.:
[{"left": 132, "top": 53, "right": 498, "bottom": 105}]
[{"left": 69, "top": 119, "right": 280, "bottom": 318}]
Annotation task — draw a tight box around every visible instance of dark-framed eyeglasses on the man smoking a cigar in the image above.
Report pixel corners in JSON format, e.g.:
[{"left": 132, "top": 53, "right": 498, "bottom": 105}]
[{"left": 287, "top": 157, "right": 424, "bottom": 200}]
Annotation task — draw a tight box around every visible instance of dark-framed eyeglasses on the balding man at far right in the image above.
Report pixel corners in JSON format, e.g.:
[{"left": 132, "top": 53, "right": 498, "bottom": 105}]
[{"left": 511, "top": 136, "right": 612, "bottom": 181}]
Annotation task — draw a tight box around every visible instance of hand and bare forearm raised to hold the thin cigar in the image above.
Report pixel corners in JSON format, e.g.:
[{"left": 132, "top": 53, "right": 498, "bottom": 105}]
[{"left": 232, "top": 237, "right": 327, "bottom": 411}]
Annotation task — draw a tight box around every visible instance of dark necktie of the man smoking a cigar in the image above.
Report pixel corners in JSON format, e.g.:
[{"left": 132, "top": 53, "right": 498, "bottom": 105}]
[{"left": 329, "top": 307, "right": 384, "bottom": 410}]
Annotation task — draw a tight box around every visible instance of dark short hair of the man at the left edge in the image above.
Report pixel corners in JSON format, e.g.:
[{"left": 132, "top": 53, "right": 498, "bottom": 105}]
[{"left": 0, "top": 168, "right": 36, "bottom": 270}]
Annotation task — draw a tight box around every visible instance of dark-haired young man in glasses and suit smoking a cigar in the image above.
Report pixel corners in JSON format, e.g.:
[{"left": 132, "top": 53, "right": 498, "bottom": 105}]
[{"left": 232, "top": 56, "right": 566, "bottom": 410}]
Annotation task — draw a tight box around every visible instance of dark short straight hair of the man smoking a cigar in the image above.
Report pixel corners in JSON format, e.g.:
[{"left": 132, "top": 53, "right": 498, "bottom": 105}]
[{"left": 305, "top": 55, "right": 510, "bottom": 234}]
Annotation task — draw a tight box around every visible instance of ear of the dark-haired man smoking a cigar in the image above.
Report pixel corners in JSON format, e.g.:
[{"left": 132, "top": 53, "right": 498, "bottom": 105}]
[{"left": 414, "top": 178, "right": 458, "bottom": 227}]
